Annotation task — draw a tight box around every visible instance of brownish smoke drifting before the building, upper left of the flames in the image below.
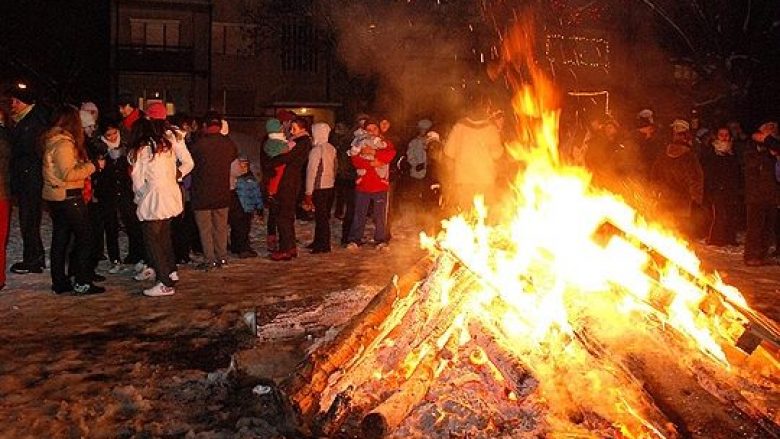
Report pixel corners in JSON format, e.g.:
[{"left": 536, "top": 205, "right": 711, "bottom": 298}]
[{"left": 318, "top": 0, "right": 479, "bottom": 124}]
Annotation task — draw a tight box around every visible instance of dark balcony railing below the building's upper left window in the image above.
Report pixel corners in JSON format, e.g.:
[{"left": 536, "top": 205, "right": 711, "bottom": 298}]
[{"left": 116, "top": 45, "right": 197, "bottom": 72}]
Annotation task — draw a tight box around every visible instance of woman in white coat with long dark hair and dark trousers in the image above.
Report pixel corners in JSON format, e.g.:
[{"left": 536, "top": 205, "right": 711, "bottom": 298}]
[{"left": 128, "top": 106, "right": 193, "bottom": 297}]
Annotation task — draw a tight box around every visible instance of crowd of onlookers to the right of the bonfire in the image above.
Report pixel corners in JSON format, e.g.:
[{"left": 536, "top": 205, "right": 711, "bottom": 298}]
[{"left": 569, "top": 109, "right": 780, "bottom": 266}]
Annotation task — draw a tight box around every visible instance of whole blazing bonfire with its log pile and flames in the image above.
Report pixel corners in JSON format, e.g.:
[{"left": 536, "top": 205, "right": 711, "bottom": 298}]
[{"left": 278, "top": 18, "right": 780, "bottom": 438}]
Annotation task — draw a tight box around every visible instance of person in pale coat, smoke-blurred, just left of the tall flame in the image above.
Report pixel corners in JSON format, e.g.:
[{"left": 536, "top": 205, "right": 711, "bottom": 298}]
[{"left": 444, "top": 105, "right": 504, "bottom": 210}]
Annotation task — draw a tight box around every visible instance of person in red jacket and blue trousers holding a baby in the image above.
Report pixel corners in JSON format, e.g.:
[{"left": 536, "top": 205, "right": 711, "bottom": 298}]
[{"left": 347, "top": 120, "right": 395, "bottom": 250}]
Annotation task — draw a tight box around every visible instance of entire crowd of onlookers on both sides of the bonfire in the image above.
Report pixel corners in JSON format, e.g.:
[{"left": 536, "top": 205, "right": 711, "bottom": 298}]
[{"left": 0, "top": 83, "right": 780, "bottom": 296}]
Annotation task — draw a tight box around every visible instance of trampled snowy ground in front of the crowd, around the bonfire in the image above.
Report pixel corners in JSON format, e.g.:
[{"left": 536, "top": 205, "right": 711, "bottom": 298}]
[{"left": 0, "top": 205, "right": 780, "bottom": 438}]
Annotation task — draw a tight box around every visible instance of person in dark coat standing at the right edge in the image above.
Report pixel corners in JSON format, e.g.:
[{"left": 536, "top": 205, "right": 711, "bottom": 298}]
[{"left": 743, "top": 121, "right": 780, "bottom": 266}]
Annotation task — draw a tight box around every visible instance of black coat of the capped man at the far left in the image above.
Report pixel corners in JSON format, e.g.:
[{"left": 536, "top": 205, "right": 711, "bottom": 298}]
[{"left": 11, "top": 105, "right": 49, "bottom": 195}]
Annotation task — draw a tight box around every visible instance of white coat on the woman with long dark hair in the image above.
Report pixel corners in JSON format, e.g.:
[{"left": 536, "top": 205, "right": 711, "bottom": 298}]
[{"left": 131, "top": 130, "right": 194, "bottom": 221}]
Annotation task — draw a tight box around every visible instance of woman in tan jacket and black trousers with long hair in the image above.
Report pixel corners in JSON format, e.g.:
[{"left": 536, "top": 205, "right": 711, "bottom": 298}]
[{"left": 41, "top": 106, "right": 105, "bottom": 295}]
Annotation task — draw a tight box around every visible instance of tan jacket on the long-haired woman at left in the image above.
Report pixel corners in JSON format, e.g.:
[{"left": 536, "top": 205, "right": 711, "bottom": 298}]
[{"left": 41, "top": 127, "right": 95, "bottom": 201}]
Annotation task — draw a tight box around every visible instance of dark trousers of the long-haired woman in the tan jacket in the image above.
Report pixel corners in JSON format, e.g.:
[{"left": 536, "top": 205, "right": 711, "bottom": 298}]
[{"left": 49, "top": 199, "right": 92, "bottom": 289}]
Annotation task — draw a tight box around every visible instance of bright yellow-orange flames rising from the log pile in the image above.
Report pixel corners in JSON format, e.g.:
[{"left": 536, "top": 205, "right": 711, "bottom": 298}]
[{"left": 421, "top": 19, "right": 746, "bottom": 437}]
